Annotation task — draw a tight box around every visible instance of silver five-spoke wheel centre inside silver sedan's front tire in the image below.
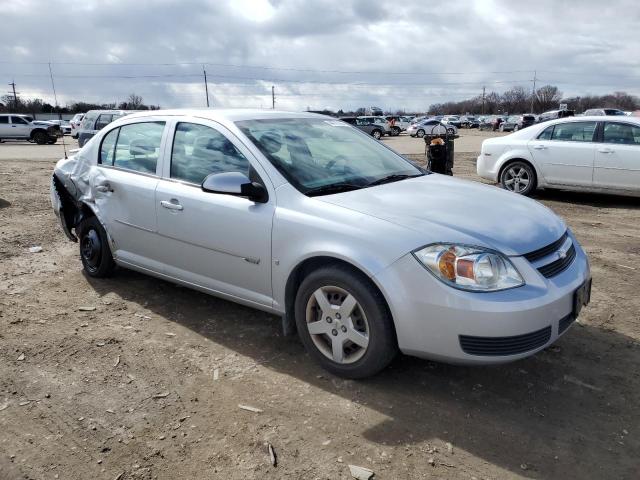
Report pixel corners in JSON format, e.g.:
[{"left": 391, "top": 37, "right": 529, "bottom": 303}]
[{"left": 306, "top": 286, "right": 370, "bottom": 364}]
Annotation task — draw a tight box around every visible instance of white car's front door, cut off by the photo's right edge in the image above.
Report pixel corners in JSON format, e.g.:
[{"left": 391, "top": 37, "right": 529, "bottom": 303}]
[{"left": 593, "top": 122, "right": 640, "bottom": 191}]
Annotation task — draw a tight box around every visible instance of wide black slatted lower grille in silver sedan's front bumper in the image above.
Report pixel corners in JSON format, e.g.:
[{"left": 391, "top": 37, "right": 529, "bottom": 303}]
[{"left": 460, "top": 326, "right": 551, "bottom": 357}]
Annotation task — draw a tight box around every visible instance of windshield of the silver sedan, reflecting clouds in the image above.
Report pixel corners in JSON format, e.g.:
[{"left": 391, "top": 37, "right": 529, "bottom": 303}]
[{"left": 236, "top": 118, "right": 423, "bottom": 195}]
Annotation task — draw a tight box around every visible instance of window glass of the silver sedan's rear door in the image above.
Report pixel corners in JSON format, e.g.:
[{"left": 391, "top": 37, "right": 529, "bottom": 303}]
[{"left": 112, "top": 122, "right": 165, "bottom": 174}]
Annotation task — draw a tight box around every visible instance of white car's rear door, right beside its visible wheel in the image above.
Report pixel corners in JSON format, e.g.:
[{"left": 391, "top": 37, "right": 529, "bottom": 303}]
[{"left": 529, "top": 122, "right": 596, "bottom": 187}]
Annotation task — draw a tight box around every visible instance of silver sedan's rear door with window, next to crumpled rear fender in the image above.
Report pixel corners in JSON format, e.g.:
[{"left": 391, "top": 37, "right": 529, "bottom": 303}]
[{"left": 93, "top": 119, "right": 165, "bottom": 272}]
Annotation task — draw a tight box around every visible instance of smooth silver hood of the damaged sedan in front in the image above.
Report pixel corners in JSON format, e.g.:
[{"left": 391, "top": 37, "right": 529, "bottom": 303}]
[{"left": 316, "top": 174, "right": 567, "bottom": 255}]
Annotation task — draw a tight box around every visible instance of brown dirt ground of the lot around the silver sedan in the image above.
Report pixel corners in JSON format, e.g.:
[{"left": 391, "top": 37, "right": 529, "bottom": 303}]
[{"left": 0, "top": 135, "right": 640, "bottom": 480}]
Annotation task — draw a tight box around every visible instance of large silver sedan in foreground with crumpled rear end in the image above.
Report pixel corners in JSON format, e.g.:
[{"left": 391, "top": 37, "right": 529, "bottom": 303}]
[{"left": 51, "top": 110, "right": 590, "bottom": 378}]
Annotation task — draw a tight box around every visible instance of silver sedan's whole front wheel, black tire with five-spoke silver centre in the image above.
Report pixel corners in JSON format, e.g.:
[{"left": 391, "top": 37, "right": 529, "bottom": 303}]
[{"left": 295, "top": 266, "right": 398, "bottom": 378}]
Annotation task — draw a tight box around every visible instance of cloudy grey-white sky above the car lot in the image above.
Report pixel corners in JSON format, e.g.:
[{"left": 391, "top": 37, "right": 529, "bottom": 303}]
[{"left": 0, "top": 0, "right": 640, "bottom": 111}]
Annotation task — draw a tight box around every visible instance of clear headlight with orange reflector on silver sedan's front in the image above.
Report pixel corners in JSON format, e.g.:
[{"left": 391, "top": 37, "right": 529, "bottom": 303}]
[{"left": 413, "top": 243, "right": 524, "bottom": 292}]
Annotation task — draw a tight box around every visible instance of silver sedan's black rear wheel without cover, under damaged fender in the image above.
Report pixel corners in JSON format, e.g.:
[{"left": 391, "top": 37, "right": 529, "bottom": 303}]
[{"left": 76, "top": 217, "right": 116, "bottom": 278}]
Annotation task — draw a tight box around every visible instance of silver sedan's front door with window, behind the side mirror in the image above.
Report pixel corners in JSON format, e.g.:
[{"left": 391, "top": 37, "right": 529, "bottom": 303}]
[{"left": 156, "top": 121, "right": 275, "bottom": 307}]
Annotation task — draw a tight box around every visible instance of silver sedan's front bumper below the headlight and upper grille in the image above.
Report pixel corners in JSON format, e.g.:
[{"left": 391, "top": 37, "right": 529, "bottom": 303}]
[{"left": 375, "top": 237, "right": 591, "bottom": 365}]
